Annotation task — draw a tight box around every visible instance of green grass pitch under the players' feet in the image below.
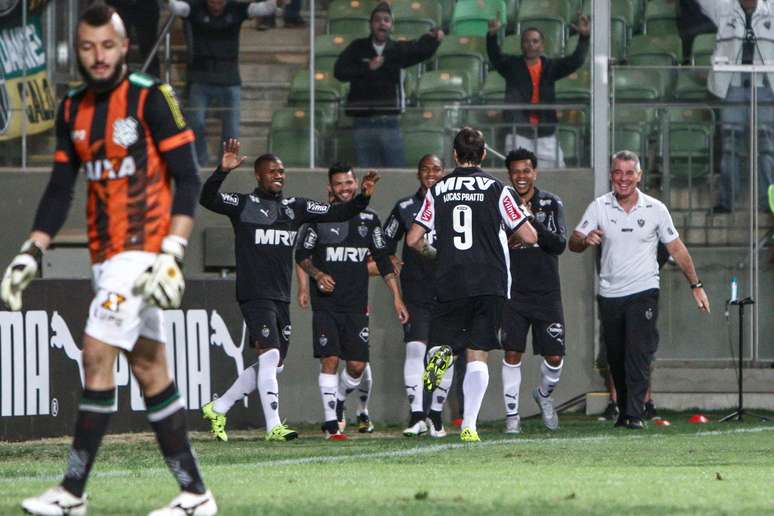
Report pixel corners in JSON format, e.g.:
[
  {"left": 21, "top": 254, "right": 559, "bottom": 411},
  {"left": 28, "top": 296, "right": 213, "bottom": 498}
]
[{"left": 0, "top": 414, "right": 774, "bottom": 515}]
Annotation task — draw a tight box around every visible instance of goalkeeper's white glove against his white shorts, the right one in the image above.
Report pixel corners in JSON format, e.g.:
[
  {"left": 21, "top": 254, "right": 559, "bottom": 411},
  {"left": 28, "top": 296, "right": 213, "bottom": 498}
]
[{"left": 134, "top": 235, "right": 188, "bottom": 310}]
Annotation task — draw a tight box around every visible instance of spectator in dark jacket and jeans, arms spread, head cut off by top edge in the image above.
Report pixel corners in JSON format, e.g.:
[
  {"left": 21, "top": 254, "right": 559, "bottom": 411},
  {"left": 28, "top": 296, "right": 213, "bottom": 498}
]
[{"left": 169, "top": 0, "right": 277, "bottom": 166}]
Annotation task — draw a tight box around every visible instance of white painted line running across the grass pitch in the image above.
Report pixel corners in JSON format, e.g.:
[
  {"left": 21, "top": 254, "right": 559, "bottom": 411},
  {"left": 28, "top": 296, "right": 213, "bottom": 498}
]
[{"left": 0, "top": 426, "right": 774, "bottom": 484}]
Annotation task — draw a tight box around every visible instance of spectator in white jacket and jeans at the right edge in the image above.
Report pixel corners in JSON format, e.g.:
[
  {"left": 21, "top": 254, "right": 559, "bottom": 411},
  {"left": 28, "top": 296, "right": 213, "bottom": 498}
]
[{"left": 696, "top": 0, "right": 774, "bottom": 213}]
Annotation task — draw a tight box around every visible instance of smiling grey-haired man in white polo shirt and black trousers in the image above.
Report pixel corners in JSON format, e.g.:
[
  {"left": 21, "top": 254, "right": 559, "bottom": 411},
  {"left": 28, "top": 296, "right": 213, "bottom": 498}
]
[{"left": 569, "top": 151, "right": 710, "bottom": 429}]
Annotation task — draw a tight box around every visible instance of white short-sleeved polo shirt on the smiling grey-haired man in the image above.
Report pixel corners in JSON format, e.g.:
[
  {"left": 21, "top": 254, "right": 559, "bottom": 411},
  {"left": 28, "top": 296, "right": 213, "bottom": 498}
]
[{"left": 575, "top": 189, "right": 678, "bottom": 297}]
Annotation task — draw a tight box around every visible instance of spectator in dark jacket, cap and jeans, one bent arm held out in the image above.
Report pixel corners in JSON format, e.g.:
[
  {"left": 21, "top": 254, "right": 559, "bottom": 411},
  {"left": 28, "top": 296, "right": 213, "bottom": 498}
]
[{"left": 334, "top": 2, "right": 444, "bottom": 168}]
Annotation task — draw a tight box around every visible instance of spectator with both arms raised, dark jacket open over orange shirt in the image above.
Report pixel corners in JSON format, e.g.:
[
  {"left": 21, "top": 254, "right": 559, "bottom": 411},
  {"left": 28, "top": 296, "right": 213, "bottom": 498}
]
[{"left": 486, "top": 16, "right": 591, "bottom": 169}]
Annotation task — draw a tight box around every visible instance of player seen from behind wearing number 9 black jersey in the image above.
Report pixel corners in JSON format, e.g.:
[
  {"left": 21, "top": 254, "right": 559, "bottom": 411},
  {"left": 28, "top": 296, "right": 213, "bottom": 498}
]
[{"left": 406, "top": 127, "right": 537, "bottom": 441}]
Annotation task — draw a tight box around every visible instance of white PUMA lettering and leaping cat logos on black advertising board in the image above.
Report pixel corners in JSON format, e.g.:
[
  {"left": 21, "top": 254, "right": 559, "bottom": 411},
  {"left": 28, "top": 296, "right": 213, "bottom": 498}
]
[{"left": 0, "top": 310, "right": 247, "bottom": 416}]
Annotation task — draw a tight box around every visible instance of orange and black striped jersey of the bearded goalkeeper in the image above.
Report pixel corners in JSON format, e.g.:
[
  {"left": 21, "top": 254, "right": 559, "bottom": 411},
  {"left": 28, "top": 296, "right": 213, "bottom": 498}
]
[{"left": 50, "top": 73, "right": 198, "bottom": 263}]
